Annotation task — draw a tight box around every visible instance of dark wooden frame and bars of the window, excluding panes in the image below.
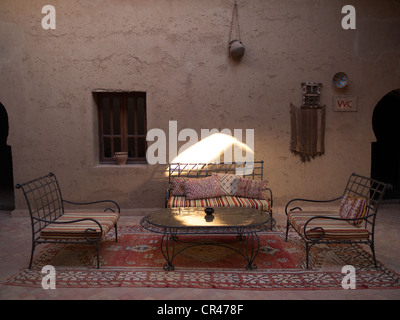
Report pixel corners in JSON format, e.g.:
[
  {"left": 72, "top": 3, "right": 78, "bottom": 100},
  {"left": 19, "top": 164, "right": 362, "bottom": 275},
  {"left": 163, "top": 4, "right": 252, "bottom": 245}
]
[{"left": 93, "top": 92, "right": 147, "bottom": 164}]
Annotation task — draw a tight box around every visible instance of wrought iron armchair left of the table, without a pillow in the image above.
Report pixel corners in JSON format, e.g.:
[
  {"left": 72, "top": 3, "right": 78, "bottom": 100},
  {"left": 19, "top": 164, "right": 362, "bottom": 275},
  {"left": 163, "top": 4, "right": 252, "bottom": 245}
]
[{"left": 16, "top": 172, "right": 120, "bottom": 269}]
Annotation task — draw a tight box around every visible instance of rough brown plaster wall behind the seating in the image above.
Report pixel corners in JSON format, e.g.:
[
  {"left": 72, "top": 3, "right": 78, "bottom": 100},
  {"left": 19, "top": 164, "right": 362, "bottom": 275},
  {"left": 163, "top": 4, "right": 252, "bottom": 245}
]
[{"left": 0, "top": 0, "right": 400, "bottom": 214}]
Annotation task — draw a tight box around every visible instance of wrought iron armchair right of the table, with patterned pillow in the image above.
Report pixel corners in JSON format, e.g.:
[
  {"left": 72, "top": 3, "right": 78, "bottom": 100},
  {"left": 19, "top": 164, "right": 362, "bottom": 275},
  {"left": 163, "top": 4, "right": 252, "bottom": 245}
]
[{"left": 285, "top": 173, "right": 392, "bottom": 269}]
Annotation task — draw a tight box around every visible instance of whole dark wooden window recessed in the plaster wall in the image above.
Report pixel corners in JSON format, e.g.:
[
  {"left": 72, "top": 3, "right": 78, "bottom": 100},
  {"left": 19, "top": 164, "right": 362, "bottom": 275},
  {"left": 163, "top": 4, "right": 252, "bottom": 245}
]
[{"left": 93, "top": 92, "right": 147, "bottom": 163}]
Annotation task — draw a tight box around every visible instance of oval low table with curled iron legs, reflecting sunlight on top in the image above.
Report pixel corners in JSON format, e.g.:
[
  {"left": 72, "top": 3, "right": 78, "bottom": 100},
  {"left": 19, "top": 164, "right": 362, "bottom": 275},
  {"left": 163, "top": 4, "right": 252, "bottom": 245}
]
[{"left": 140, "top": 207, "right": 275, "bottom": 271}]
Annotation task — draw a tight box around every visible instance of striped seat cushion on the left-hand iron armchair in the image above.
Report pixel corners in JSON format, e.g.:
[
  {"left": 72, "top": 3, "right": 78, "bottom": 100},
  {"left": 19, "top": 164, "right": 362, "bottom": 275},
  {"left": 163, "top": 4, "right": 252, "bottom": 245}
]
[{"left": 40, "top": 212, "right": 119, "bottom": 240}]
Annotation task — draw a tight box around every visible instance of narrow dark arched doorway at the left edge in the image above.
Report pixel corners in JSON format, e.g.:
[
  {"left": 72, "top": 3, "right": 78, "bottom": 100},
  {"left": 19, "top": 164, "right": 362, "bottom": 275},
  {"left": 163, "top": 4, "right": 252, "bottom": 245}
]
[{"left": 0, "top": 102, "right": 15, "bottom": 211}]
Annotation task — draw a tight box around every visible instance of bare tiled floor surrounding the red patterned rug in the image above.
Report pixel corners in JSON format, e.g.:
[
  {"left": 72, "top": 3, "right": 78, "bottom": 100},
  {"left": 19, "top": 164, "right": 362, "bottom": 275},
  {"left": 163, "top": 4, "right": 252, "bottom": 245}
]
[{"left": 0, "top": 205, "right": 400, "bottom": 300}]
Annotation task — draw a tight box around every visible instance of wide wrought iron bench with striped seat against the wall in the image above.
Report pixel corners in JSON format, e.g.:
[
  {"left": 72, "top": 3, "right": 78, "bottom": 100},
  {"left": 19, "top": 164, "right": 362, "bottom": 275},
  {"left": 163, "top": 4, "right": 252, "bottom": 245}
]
[{"left": 165, "top": 161, "right": 273, "bottom": 226}]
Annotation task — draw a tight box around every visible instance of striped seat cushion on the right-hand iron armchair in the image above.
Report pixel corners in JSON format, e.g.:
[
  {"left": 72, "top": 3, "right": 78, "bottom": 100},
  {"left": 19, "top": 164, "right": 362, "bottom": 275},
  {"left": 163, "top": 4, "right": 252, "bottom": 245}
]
[{"left": 288, "top": 211, "right": 369, "bottom": 240}]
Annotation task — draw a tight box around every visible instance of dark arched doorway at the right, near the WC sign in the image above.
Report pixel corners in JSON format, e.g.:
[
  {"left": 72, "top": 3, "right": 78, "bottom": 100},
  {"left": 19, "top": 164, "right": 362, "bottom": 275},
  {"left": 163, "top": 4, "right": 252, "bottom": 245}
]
[{"left": 371, "top": 89, "right": 400, "bottom": 201}]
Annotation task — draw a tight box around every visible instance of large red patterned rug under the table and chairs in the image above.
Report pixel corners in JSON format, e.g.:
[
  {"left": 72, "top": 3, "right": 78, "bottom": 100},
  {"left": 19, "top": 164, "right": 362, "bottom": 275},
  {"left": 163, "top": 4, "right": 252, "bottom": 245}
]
[{"left": 4, "top": 226, "right": 400, "bottom": 290}]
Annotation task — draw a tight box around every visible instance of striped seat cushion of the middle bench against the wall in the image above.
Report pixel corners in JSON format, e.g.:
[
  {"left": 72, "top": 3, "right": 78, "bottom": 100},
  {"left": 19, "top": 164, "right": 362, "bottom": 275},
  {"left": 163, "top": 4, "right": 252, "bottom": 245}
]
[{"left": 168, "top": 196, "right": 271, "bottom": 211}]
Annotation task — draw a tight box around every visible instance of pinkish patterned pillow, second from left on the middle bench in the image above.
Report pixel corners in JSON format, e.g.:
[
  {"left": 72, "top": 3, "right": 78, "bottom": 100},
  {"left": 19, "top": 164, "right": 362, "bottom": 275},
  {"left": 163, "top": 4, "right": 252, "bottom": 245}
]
[{"left": 184, "top": 176, "right": 224, "bottom": 200}]
